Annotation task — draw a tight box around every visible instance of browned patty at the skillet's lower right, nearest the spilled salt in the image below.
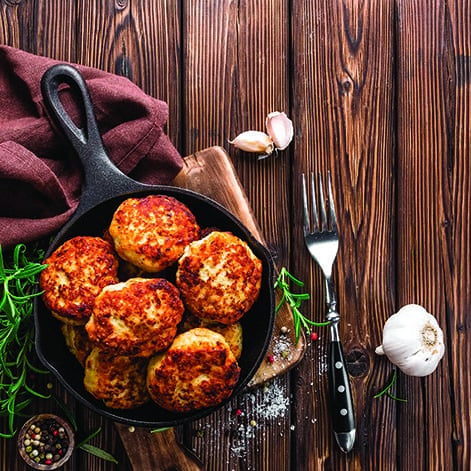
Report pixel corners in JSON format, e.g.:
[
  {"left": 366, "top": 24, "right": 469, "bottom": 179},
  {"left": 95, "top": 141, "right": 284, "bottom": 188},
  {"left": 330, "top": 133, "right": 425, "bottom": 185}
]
[{"left": 147, "top": 328, "right": 240, "bottom": 412}]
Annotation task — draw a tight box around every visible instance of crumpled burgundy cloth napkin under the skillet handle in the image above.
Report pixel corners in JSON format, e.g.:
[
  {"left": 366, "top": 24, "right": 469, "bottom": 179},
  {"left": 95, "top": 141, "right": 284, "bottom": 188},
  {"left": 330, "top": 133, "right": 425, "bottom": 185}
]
[{"left": 0, "top": 46, "right": 183, "bottom": 247}]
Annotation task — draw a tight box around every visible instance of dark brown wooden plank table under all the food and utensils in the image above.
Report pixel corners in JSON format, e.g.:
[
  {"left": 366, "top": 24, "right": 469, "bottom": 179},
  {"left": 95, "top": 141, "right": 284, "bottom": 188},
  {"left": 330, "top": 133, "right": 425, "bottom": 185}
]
[{"left": 0, "top": 0, "right": 471, "bottom": 471}]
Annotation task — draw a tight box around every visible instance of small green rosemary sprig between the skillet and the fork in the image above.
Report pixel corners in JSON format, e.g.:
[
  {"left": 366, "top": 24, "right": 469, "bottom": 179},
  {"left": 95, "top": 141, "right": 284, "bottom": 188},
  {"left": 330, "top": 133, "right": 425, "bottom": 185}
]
[{"left": 275, "top": 267, "right": 329, "bottom": 343}]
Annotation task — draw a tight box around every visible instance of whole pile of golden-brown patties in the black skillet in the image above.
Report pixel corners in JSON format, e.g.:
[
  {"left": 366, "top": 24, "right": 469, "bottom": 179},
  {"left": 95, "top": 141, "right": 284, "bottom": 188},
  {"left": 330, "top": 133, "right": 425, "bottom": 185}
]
[{"left": 40, "top": 195, "right": 262, "bottom": 412}]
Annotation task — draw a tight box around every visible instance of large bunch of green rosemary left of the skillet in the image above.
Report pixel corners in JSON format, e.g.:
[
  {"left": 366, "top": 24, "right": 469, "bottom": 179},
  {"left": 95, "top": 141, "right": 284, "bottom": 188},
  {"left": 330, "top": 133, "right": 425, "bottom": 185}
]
[{"left": 0, "top": 244, "right": 48, "bottom": 438}]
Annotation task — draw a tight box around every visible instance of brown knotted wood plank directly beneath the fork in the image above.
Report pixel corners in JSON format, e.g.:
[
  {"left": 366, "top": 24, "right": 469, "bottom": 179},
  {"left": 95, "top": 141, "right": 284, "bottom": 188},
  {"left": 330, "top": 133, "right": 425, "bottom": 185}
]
[{"left": 292, "top": 1, "right": 396, "bottom": 470}]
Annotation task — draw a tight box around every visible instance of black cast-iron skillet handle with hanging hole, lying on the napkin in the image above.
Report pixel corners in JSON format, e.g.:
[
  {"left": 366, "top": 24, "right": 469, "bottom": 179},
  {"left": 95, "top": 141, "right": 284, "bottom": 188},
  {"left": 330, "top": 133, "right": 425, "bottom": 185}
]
[{"left": 41, "top": 64, "right": 138, "bottom": 210}]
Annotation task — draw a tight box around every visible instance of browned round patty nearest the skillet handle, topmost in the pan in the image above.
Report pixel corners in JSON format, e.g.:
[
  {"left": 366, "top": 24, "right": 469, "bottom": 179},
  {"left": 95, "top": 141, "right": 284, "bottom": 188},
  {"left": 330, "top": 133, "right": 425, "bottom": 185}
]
[{"left": 109, "top": 195, "right": 200, "bottom": 273}]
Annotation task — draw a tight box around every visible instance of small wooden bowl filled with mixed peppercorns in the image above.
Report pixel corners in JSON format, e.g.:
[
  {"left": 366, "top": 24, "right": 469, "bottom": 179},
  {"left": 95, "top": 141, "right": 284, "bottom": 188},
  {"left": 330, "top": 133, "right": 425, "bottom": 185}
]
[{"left": 18, "top": 414, "right": 75, "bottom": 470}]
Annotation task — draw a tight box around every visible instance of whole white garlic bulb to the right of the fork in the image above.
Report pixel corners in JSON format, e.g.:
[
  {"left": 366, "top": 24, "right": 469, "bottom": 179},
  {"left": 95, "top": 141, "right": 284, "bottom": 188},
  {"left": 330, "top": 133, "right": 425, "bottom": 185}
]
[{"left": 376, "top": 304, "right": 445, "bottom": 376}]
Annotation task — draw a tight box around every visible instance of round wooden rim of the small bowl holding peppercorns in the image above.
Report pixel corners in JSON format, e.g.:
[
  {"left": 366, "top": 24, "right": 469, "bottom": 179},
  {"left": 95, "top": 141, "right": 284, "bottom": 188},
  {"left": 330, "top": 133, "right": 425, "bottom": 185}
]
[{"left": 17, "top": 414, "right": 75, "bottom": 471}]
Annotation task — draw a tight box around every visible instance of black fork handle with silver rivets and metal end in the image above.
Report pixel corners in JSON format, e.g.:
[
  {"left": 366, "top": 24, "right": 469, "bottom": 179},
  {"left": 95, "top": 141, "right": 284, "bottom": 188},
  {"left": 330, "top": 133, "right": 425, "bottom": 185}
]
[{"left": 329, "top": 332, "right": 355, "bottom": 453}]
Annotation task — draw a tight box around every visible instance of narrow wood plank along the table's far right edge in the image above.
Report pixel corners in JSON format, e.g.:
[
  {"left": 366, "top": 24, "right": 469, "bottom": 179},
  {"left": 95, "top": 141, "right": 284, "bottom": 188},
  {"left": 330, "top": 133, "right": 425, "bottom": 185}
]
[{"left": 448, "top": 1, "right": 471, "bottom": 469}]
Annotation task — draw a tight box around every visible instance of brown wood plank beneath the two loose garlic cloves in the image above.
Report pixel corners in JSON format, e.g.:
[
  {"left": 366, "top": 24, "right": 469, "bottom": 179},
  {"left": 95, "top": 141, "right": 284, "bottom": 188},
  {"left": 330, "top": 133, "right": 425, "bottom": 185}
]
[{"left": 182, "top": 0, "right": 291, "bottom": 471}]
